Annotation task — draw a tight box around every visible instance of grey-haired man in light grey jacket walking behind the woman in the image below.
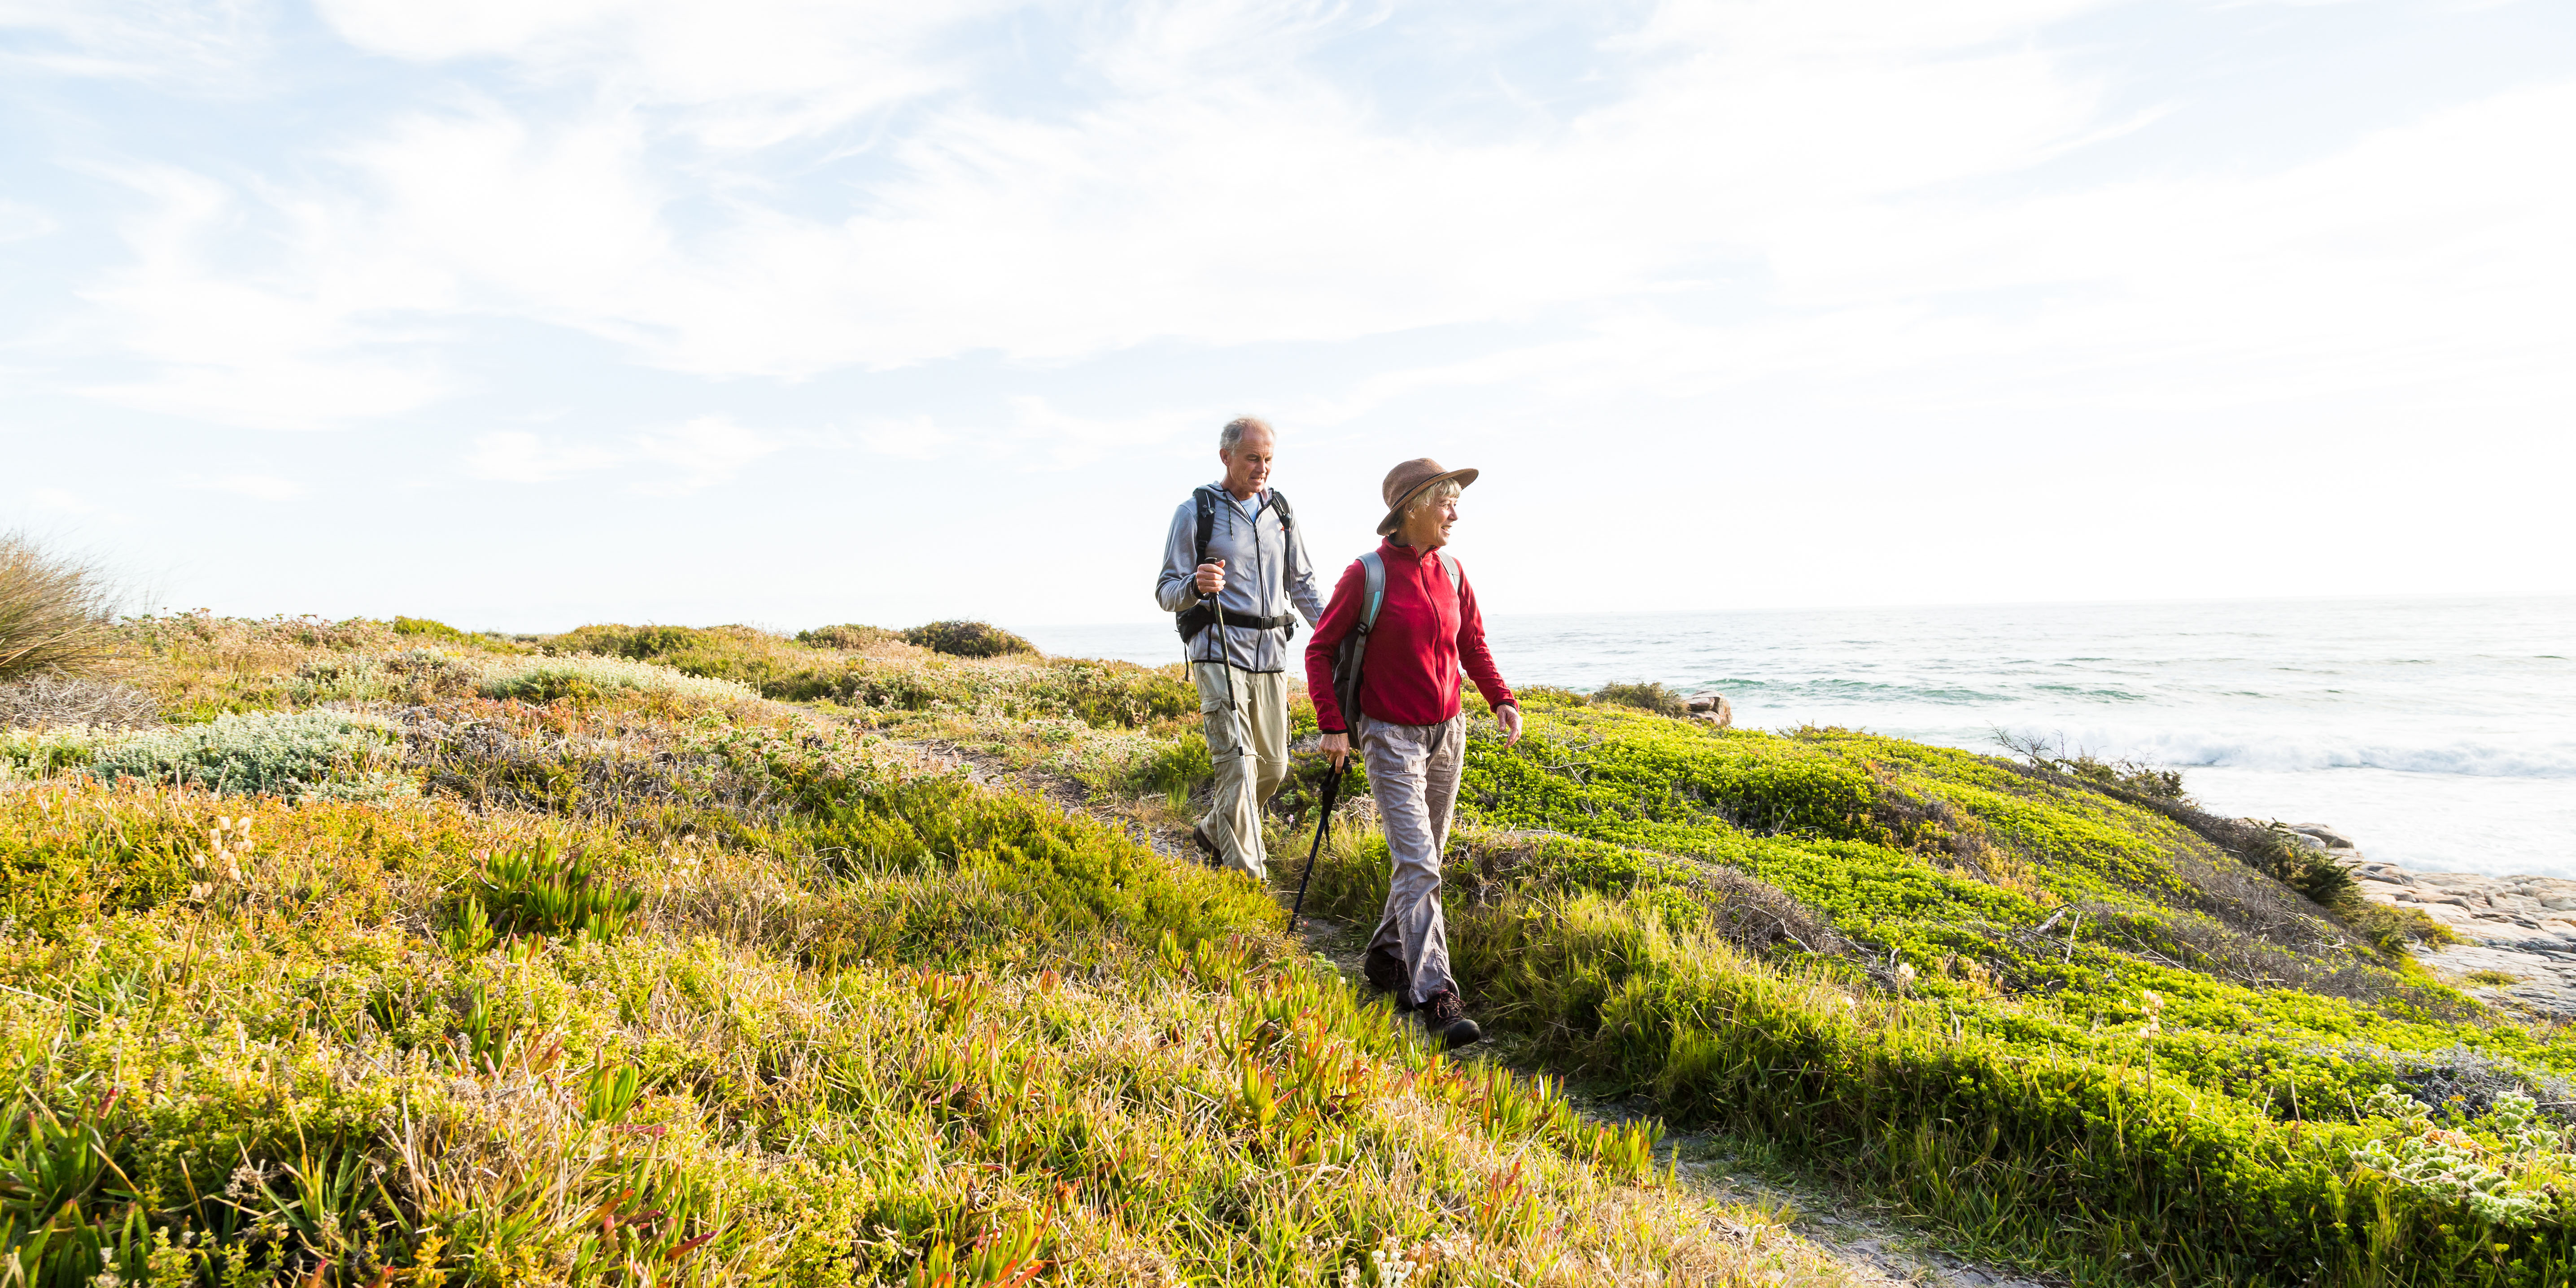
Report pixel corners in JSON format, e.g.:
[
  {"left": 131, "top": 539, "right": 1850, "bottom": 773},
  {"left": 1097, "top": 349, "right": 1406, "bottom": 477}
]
[{"left": 1154, "top": 415, "right": 1324, "bottom": 878}]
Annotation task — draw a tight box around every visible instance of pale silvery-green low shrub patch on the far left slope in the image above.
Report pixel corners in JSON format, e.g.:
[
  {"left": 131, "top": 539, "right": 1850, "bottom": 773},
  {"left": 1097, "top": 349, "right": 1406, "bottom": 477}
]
[{"left": 87, "top": 711, "right": 412, "bottom": 799}]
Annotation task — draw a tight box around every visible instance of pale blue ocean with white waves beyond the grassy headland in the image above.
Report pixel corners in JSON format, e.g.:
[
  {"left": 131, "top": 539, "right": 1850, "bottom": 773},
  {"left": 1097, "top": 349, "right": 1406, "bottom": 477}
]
[{"left": 1023, "top": 598, "right": 2576, "bottom": 878}]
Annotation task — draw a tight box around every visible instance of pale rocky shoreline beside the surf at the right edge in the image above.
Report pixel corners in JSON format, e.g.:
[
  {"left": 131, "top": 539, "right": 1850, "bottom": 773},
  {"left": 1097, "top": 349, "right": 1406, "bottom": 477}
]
[{"left": 2290, "top": 822, "right": 2576, "bottom": 1020}]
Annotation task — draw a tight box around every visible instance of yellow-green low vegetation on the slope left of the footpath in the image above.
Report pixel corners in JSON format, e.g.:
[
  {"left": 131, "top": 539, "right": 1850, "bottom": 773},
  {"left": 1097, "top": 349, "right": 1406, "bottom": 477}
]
[{"left": 0, "top": 616, "right": 1875, "bottom": 1288}]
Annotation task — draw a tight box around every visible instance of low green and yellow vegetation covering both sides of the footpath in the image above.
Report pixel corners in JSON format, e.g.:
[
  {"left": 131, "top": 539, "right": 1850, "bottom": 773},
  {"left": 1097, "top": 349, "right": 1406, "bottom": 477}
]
[{"left": 20, "top": 616, "right": 2576, "bottom": 1288}]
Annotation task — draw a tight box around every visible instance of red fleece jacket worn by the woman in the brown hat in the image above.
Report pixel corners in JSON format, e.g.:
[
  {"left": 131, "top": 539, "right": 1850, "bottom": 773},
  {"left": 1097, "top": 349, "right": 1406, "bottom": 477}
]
[{"left": 1306, "top": 541, "right": 1515, "bottom": 734}]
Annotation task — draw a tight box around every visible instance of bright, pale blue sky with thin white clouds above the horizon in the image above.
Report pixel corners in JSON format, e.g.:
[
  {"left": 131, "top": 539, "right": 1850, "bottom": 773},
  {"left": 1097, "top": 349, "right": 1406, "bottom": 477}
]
[{"left": 0, "top": 0, "right": 2576, "bottom": 631}]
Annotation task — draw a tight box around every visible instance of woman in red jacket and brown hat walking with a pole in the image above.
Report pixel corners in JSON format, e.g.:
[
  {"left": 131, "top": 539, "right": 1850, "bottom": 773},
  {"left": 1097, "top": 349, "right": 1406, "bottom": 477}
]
[{"left": 1306, "top": 456, "right": 1520, "bottom": 1048}]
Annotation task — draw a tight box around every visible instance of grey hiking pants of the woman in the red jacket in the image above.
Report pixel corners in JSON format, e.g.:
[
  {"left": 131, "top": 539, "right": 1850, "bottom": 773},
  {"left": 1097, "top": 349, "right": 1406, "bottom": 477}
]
[{"left": 1358, "top": 711, "right": 1466, "bottom": 1004}]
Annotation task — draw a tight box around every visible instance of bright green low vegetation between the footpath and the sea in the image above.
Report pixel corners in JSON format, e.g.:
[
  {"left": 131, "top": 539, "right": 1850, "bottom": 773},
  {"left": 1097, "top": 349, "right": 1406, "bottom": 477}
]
[{"left": 1288, "top": 695, "right": 2576, "bottom": 1285}]
